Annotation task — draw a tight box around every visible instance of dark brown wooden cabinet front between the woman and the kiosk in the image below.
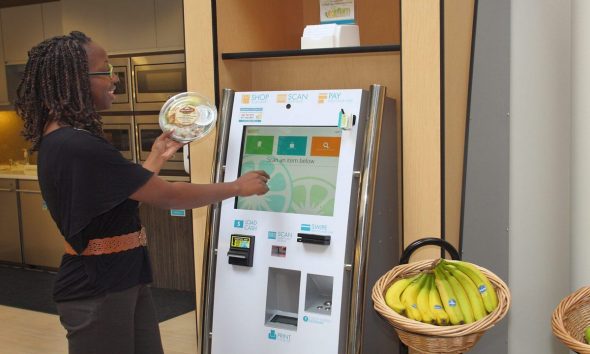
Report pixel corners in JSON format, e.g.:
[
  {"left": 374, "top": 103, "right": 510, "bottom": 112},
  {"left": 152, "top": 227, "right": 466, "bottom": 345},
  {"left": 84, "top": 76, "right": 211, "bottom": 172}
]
[{"left": 139, "top": 203, "right": 195, "bottom": 291}]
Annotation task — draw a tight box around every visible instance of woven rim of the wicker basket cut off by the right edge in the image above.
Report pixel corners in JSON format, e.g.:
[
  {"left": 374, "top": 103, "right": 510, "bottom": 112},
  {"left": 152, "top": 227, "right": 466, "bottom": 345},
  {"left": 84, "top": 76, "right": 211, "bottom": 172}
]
[{"left": 551, "top": 286, "right": 590, "bottom": 354}]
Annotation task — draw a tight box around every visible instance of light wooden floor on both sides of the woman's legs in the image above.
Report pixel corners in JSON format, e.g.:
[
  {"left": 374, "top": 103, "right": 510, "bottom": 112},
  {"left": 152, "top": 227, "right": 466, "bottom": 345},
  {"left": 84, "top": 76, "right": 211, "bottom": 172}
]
[{"left": 0, "top": 305, "right": 197, "bottom": 354}]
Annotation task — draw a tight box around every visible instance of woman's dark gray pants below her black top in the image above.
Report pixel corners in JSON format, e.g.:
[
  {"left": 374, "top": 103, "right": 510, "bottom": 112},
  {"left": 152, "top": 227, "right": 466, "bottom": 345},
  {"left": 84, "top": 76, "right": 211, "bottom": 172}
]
[{"left": 57, "top": 285, "right": 164, "bottom": 354}]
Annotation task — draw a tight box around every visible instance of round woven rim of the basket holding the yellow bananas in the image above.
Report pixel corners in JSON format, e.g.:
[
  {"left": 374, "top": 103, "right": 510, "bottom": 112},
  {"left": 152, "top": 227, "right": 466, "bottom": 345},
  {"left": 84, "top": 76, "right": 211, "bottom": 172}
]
[{"left": 372, "top": 259, "right": 511, "bottom": 337}]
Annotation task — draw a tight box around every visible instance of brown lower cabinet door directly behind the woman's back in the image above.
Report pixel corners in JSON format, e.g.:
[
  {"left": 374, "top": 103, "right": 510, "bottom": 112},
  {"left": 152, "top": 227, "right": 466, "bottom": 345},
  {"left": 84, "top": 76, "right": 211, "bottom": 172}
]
[{"left": 17, "top": 180, "right": 64, "bottom": 268}]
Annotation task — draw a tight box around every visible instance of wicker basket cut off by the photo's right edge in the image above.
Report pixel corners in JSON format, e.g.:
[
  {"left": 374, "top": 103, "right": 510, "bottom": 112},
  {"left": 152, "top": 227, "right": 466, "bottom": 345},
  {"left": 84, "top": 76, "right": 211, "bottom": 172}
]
[{"left": 551, "top": 286, "right": 590, "bottom": 354}]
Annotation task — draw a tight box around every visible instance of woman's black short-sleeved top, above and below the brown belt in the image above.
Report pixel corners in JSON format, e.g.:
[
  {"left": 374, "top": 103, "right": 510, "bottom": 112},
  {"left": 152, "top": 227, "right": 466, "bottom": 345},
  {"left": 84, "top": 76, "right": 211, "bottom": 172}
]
[{"left": 38, "top": 127, "right": 153, "bottom": 301}]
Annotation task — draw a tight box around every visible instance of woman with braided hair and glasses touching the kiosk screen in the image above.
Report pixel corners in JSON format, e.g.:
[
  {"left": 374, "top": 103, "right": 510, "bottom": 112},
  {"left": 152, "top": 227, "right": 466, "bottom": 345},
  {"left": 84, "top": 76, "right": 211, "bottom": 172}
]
[{"left": 16, "top": 32, "right": 268, "bottom": 354}]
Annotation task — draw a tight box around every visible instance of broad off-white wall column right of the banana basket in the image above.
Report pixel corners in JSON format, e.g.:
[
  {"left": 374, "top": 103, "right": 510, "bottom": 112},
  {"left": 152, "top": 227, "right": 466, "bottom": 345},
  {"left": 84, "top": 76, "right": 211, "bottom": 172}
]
[{"left": 508, "top": 0, "right": 572, "bottom": 354}]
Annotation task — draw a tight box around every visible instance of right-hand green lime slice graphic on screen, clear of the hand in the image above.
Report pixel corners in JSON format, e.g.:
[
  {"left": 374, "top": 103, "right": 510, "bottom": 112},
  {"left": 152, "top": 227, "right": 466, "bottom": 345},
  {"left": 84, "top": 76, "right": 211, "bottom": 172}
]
[{"left": 289, "top": 177, "right": 336, "bottom": 216}]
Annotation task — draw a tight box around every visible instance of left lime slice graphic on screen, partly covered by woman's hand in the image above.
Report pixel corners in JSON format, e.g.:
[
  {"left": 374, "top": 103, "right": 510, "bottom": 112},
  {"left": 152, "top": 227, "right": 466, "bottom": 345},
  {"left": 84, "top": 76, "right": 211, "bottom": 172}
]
[{"left": 238, "top": 156, "right": 291, "bottom": 212}]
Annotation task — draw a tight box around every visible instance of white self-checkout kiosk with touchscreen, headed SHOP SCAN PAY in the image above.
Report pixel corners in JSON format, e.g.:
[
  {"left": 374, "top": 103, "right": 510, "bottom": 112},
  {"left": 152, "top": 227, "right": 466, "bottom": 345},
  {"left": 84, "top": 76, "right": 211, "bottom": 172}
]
[{"left": 202, "top": 85, "right": 400, "bottom": 354}]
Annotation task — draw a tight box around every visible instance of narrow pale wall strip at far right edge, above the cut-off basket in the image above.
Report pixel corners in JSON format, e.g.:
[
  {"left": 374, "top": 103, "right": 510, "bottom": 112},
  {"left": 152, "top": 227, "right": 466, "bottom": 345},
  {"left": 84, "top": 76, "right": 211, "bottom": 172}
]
[{"left": 571, "top": 0, "right": 590, "bottom": 291}]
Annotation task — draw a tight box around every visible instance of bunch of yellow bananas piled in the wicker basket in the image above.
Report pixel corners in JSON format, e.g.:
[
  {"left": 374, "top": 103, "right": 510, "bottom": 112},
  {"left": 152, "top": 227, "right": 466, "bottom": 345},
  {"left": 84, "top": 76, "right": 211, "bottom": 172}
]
[{"left": 385, "top": 259, "right": 498, "bottom": 326}]
